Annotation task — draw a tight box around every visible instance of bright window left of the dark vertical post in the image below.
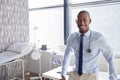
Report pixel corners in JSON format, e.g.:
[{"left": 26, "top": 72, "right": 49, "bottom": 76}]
[{"left": 29, "top": 0, "right": 64, "bottom": 48}]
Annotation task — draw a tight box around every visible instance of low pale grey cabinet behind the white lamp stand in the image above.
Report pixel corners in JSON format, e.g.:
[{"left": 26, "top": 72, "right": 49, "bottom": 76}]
[{"left": 26, "top": 50, "right": 63, "bottom": 73}]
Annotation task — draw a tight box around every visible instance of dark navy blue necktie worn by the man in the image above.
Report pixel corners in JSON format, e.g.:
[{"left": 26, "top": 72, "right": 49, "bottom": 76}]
[{"left": 78, "top": 35, "right": 84, "bottom": 75}]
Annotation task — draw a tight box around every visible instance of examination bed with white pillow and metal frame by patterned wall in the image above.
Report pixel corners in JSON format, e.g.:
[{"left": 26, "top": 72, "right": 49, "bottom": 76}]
[{"left": 0, "top": 42, "right": 33, "bottom": 80}]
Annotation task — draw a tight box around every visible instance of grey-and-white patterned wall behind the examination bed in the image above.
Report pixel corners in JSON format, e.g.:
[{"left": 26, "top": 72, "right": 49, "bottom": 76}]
[{"left": 0, "top": 0, "right": 29, "bottom": 52}]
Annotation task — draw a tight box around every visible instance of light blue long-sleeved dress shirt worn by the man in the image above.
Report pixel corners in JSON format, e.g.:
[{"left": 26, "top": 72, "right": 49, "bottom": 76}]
[{"left": 61, "top": 30, "right": 117, "bottom": 80}]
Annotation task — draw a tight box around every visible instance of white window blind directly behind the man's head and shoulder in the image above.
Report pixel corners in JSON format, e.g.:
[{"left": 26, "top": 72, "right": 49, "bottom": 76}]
[{"left": 71, "top": 2, "right": 120, "bottom": 51}]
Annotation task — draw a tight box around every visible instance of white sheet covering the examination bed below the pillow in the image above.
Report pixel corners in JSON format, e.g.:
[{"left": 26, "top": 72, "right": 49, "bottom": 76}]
[{"left": 0, "top": 47, "right": 33, "bottom": 65}]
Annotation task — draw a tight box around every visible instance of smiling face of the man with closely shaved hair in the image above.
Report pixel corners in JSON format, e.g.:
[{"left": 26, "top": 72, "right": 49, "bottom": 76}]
[{"left": 76, "top": 13, "right": 91, "bottom": 34}]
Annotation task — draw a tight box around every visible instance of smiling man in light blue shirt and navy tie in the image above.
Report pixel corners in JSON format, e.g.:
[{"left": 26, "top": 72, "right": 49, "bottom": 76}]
[{"left": 61, "top": 10, "right": 117, "bottom": 80}]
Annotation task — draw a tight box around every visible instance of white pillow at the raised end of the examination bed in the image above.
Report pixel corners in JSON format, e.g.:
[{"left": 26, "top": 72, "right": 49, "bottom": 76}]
[{"left": 7, "top": 42, "right": 32, "bottom": 53}]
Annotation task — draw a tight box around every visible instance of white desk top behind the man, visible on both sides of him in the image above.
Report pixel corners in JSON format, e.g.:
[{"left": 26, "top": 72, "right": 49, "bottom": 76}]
[{"left": 42, "top": 67, "right": 117, "bottom": 80}]
